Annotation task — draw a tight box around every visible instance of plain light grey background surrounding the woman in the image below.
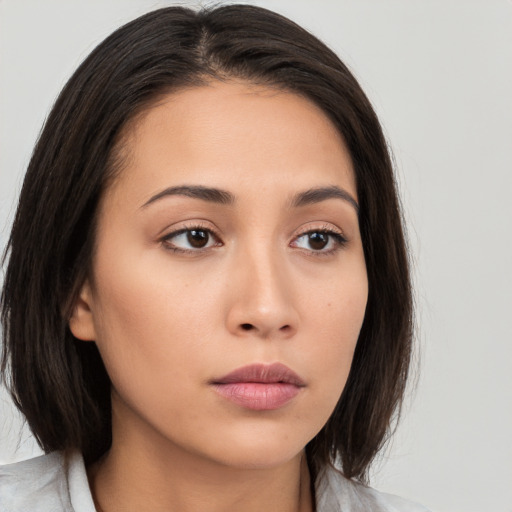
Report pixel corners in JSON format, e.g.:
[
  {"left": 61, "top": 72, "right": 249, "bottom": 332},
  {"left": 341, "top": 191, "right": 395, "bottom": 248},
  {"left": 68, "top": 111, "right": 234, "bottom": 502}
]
[{"left": 0, "top": 0, "right": 512, "bottom": 512}]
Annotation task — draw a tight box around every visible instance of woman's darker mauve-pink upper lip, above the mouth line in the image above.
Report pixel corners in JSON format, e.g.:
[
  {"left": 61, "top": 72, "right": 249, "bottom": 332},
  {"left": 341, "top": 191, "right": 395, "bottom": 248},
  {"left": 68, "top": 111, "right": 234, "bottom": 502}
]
[{"left": 213, "top": 363, "right": 306, "bottom": 387}]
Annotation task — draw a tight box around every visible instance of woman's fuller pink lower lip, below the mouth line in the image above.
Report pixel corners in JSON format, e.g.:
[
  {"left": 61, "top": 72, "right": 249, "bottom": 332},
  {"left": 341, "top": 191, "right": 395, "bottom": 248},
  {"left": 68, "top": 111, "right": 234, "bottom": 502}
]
[{"left": 213, "top": 382, "right": 301, "bottom": 411}]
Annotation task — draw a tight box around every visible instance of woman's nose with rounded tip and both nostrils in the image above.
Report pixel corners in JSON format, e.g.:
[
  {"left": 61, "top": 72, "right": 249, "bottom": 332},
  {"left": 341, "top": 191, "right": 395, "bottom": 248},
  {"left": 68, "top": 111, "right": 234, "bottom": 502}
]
[{"left": 226, "top": 244, "right": 299, "bottom": 339}]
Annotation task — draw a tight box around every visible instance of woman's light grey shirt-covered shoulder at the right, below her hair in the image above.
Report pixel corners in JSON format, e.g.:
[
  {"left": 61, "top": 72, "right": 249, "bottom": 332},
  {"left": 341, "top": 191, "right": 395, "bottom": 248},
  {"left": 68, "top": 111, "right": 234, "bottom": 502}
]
[{"left": 316, "top": 468, "right": 429, "bottom": 512}]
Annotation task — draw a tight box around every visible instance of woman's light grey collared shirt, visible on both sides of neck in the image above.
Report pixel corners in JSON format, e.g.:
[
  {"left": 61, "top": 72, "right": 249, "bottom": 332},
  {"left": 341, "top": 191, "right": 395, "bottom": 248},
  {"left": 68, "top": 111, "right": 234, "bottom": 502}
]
[{"left": 0, "top": 452, "right": 428, "bottom": 512}]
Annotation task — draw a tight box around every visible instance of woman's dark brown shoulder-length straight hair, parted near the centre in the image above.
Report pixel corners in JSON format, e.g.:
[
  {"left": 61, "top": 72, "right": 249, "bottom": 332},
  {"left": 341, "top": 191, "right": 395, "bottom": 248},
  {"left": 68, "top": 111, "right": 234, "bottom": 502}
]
[{"left": 2, "top": 5, "right": 412, "bottom": 481}]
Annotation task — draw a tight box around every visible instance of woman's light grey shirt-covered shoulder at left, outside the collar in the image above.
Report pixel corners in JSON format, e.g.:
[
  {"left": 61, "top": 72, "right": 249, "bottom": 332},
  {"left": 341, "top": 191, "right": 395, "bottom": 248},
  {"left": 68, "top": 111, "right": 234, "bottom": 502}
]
[{"left": 0, "top": 452, "right": 77, "bottom": 512}]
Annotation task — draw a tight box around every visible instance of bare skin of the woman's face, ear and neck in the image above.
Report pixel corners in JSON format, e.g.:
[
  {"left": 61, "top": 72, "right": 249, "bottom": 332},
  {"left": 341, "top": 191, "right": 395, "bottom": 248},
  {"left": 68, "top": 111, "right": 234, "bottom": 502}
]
[{"left": 70, "top": 81, "right": 368, "bottom": 512}]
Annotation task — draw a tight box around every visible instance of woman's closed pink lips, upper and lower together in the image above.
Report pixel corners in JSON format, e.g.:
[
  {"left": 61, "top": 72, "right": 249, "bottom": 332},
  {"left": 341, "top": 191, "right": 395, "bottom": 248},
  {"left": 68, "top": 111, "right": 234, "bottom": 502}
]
[{"left": 211, "top": 363, "right": 306, "bottom": 411}]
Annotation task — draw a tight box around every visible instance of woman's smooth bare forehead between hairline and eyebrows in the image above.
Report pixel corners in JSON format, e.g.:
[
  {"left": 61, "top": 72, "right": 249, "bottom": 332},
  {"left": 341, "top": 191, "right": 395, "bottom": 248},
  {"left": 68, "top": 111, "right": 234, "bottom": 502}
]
[{"left": 108, "top": 81, "right": 356, "bottom": 205}]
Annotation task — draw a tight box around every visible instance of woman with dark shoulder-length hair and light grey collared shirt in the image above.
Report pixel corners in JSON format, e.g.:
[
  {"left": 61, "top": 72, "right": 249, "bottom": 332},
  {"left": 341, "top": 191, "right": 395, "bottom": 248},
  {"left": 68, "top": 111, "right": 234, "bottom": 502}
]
[{"left": 0, "top": 6, "right": 424, "bottom": 512}]
